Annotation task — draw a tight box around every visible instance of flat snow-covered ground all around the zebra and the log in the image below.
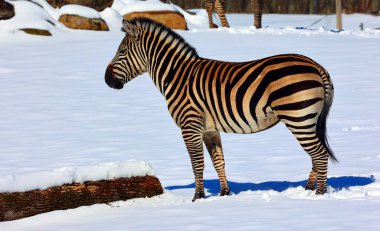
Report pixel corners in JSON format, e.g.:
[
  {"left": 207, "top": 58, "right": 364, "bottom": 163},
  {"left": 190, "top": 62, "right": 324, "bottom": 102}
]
[{"left": 0, "top": 14, "right": 380, "bottom": 231}]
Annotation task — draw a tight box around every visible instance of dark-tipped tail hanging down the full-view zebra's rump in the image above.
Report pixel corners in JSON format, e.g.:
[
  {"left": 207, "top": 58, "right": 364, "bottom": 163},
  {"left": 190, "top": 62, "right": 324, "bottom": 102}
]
[{"left": 316, "top": 68, "right": 339, "bottom": 163}]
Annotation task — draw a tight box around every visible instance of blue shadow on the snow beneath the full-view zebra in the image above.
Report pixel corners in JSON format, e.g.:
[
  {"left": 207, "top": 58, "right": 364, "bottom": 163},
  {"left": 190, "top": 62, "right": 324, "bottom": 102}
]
[{"left": 165, "top": 175, "right": 376, "bottom": 196}]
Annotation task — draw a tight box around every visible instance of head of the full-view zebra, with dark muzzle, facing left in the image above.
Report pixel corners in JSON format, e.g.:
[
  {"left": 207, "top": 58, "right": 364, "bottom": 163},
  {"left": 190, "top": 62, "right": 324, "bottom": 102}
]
[{"left": 104, "top": 20, "right": 146, "bottom": 89}]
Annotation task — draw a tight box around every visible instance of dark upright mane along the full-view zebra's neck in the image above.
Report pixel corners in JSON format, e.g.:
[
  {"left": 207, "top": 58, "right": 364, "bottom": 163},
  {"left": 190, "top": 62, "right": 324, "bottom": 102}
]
[{"left": 129, "top": 17, "right": 198, "bottom": 57}]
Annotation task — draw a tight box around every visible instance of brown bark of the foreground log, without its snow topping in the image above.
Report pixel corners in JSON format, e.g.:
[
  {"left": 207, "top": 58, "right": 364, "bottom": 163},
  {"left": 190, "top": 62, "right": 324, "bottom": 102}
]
[{"left": 0, "top": 175, "right": 163, "bottom": 221}]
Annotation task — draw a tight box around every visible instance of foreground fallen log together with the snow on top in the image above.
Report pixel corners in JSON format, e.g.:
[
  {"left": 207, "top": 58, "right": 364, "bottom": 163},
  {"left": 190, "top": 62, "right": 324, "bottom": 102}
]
[{"left": 0, "top": 161, "right": 163, "bottom": 221}]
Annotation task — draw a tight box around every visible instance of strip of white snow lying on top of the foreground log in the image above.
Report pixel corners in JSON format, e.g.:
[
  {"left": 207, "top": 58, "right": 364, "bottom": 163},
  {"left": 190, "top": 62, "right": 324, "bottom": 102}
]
[{"left": 0, "top": 160, "right": 155, "bottom": 192}]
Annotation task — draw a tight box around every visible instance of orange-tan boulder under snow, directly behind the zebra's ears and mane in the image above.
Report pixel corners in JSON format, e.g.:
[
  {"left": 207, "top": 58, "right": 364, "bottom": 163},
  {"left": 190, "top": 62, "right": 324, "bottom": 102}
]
[{"left": 123, "top": 11, "right": 187, "bottom": 30}]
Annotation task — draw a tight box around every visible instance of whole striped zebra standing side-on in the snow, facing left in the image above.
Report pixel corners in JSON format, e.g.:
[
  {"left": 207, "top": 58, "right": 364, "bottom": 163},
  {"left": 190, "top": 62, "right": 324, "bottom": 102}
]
[{"left": 105, "top": 18, "right": 337, "bottom": 201}]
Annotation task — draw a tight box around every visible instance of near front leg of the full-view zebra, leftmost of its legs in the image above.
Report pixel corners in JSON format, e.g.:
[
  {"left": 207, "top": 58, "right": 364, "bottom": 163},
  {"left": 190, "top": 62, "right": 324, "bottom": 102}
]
[{"left": 182, "top": 129, "right": 205, "bottom": 202}]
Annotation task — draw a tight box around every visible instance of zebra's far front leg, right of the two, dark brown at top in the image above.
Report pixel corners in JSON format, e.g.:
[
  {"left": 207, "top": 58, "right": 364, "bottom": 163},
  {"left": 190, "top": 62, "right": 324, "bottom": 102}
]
[{"left": 203, "top": 132, "right": 230, "bottom": 196}]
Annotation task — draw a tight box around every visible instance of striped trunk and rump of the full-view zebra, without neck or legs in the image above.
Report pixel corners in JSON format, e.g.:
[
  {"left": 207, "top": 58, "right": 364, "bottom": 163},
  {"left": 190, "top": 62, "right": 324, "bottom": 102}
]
[{"left": 190, "top": 55, "right": 329, "bottom": 133}]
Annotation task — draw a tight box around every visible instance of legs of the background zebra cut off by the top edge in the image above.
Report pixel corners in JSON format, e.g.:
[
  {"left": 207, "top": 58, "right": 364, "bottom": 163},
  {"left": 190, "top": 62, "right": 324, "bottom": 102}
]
[{"left": 203, "top": 0, "right": 264, "bottom": 29}]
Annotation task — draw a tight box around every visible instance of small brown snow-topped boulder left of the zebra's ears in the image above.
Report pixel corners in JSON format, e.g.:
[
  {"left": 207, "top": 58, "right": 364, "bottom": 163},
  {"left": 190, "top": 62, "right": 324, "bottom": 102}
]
[{"left": 58, "top": 14, "right": 109, "bottom": 31}]
